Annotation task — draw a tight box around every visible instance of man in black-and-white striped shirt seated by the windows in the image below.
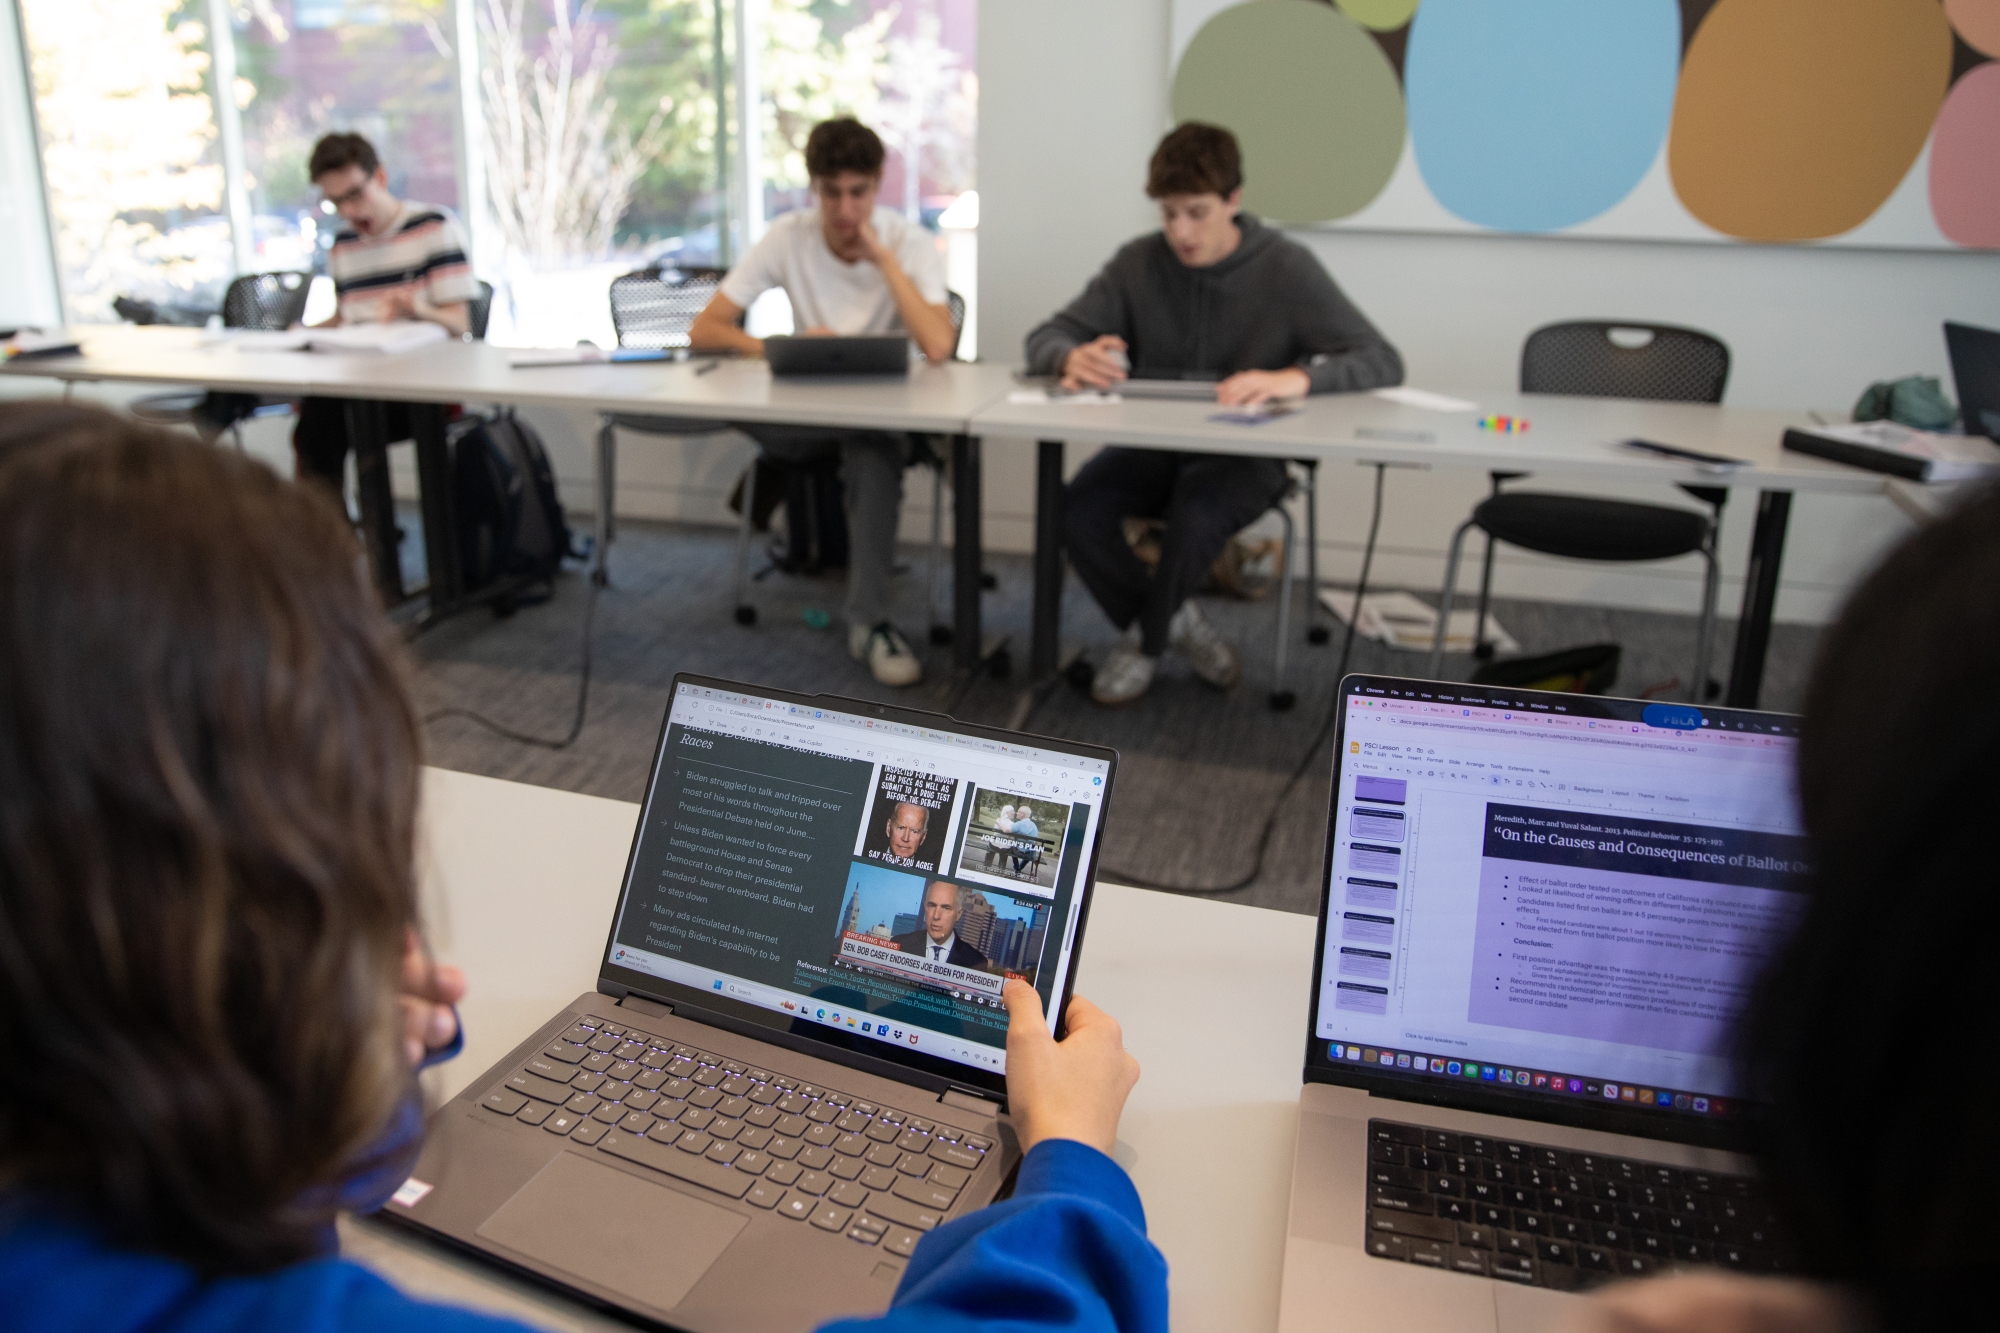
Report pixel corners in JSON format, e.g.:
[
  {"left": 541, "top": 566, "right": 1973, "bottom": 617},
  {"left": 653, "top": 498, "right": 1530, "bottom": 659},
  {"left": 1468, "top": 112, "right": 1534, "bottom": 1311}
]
[{"left": 292, "top": 134, "right": 478, "bottom": 490}]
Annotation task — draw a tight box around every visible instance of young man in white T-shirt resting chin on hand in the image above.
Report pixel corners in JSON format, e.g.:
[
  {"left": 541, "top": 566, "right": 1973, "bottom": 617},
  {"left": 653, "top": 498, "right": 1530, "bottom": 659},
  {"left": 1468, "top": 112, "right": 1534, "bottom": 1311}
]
[{"left": 688, "top": 116, "right": 958, "bottom": 685}]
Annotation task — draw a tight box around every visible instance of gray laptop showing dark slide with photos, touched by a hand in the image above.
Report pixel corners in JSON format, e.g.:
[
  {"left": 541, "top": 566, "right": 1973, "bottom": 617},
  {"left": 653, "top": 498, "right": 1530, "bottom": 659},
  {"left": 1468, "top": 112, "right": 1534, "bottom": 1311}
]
[{"left": 384, "top": 675, "right": 1118, "bottom": 1333}]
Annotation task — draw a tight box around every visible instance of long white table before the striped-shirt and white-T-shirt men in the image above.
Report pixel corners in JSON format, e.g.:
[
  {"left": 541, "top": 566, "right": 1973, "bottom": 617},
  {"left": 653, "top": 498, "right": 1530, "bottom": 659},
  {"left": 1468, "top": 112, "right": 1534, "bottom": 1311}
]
[{"left": 0, "top": 324, "right": 1012, "bottom": 664}]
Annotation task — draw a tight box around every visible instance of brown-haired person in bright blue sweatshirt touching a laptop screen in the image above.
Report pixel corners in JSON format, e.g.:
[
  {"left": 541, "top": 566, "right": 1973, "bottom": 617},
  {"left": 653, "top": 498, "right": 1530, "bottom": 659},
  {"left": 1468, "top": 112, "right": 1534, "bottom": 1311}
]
[{"left": 0, "top": 404, "right": 1166, "bottom": 1333}]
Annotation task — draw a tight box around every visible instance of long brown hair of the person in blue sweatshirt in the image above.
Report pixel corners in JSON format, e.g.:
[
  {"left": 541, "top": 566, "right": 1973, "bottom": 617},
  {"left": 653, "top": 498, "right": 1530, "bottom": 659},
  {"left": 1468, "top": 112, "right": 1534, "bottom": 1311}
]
[{"left": 0, "top": 402, "right": 420, "bottom": 1273}]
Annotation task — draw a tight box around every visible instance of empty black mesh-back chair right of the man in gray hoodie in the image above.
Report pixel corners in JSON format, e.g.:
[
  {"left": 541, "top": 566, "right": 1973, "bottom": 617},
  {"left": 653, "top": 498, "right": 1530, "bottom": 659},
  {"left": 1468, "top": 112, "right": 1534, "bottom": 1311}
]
[{"left": 1430, "top": 320, "right": 1730, "bottom": 703}]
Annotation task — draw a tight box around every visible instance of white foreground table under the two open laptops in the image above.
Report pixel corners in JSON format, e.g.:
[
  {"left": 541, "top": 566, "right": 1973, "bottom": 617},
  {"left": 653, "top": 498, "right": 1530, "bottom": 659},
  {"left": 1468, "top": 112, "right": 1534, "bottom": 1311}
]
[{"left": 342, "top": 769, "right": 1314, "bottom": 1333}]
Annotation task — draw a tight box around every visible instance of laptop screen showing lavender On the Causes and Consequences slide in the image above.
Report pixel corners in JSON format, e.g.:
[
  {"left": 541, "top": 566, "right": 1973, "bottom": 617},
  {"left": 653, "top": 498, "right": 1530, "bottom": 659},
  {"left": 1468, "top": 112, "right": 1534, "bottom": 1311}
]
[{"left": 1306, "top": 677, "right": 1806, "bottom": 1143}]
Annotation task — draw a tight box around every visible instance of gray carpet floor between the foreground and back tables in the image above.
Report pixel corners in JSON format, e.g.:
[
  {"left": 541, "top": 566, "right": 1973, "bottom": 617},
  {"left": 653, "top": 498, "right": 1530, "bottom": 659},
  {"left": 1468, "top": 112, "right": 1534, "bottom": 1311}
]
[{"left": 408, "top": 514, "right": 1818, "bottom": 915}]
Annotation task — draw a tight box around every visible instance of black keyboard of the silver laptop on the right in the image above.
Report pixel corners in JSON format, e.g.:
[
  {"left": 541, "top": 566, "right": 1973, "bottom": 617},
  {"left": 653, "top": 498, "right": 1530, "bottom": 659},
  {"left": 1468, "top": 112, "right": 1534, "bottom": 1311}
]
[{"left": 1368, "top": 1121, "right": 1784, "bottom": 1291}]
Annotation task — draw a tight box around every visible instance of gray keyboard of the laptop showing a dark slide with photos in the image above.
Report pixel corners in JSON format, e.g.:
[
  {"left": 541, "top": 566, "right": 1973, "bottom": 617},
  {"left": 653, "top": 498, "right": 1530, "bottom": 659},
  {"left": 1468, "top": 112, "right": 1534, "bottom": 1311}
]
[{"left": 480, "top": 1015, "right": 992, "bottom": 1259}]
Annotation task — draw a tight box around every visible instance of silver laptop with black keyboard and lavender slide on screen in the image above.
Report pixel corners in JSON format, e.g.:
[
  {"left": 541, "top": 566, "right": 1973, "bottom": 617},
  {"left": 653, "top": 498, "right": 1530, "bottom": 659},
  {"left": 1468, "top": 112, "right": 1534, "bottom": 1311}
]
[{"left": 1280, "top": 677, "right": 1806, "bottom": 1329}]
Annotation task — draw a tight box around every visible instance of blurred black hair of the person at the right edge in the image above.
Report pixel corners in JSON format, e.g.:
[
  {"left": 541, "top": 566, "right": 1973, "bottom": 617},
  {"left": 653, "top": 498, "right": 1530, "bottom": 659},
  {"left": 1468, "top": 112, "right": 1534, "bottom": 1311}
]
[{"left": 1744, "top": 480, "right": 2000, "bottom": 1296}]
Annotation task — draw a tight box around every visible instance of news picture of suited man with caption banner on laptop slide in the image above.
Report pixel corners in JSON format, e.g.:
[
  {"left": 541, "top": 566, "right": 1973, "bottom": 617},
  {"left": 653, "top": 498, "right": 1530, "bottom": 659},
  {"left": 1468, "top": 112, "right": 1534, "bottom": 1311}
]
[{"left": 832, "top": 861, "right": 1050, "bottom": 1007}]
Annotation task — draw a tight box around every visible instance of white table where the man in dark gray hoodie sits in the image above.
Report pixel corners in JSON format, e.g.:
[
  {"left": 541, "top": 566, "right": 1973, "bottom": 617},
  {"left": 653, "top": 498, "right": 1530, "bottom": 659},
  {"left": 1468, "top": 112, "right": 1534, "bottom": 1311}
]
[{"left": 970, "top": 394, "right": 1886, "bottom": 709}]
